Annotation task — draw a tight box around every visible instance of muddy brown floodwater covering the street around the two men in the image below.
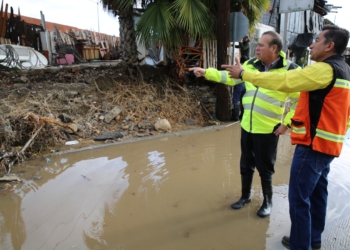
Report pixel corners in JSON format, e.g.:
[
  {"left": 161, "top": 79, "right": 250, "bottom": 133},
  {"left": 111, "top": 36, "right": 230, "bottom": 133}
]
[{"left": 0, "top": 124, "right": 350, "bottom": 250}]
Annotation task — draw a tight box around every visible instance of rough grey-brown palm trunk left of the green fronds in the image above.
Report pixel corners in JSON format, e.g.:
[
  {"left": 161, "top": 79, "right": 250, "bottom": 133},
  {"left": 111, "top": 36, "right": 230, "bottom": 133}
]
[{"left": 119, "top": 6, "right": 138, "bottom": 65}]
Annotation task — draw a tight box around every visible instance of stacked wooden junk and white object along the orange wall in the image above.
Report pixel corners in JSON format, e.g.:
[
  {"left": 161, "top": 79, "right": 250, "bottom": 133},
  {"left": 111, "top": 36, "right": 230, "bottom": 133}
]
[{"left": 0, "top": 0, "right": 119, "bottom": 70}]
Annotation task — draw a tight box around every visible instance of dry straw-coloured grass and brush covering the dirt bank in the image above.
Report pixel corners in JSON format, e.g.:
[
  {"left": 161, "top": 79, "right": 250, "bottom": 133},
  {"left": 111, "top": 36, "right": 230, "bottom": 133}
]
[{"left": 0, "top": 76, "right": 208, "bottom": 174}]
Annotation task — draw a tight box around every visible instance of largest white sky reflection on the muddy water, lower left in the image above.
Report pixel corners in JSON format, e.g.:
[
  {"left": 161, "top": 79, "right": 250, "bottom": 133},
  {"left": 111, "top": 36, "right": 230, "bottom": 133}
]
[{"left": 22, "top": 157, "right": 129, "bottom": 249}]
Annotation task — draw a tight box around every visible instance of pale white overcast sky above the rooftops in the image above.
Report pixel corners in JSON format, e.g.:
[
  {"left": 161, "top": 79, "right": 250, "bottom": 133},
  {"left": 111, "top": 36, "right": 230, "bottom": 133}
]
[{"left": 4, "top": 0, "right": 350, "bottom": 43}]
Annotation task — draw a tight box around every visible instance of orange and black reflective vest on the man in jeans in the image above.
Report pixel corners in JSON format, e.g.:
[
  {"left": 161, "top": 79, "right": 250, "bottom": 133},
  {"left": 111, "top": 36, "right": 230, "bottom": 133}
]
[{"left": 291, "top": 56, "right": 350, "bottom": 156}]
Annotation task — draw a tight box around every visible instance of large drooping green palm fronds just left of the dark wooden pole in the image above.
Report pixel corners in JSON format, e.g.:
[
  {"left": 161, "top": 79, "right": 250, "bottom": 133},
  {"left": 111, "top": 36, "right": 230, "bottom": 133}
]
[{"left": 136, "top": 0, "right": 215, "bottom": 49}]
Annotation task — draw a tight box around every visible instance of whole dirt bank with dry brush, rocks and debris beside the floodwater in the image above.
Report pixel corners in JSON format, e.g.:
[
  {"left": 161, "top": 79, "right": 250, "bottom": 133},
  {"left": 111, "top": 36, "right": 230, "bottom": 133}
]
[{"left": 0, "top": 64, "right": 219, "bottom": 176}]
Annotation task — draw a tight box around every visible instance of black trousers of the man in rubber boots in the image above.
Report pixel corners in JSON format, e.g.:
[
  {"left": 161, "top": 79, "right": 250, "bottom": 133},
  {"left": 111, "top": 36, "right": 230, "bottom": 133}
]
[{"left": 240, "top": 129, "right": 279, "bottom": 181}]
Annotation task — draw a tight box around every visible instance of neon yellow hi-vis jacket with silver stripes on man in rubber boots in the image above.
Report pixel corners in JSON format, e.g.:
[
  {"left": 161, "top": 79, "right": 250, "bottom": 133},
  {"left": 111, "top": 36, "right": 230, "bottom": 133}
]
[{"left": 205, "top": 51, "right": 300, "bottom": 134}]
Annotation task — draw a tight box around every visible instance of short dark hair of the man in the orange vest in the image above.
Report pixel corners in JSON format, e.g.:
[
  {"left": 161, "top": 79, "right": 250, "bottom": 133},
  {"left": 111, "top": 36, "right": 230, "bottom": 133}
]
[{"left": 322, "top": 25, "right": 349, "bottom": 55}]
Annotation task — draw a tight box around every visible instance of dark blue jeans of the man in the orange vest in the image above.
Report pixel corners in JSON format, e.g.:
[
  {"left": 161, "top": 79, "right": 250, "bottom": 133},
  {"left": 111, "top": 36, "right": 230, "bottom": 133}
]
[{"left": 288, "top": 145, "right": 334, "bottom": 250}]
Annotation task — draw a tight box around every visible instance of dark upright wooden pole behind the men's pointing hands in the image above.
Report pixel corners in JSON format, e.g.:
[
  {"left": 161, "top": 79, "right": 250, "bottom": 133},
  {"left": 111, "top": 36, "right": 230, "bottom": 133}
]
[{"left": 215, "top": 0, "right": 231, "bottom": 121}]
